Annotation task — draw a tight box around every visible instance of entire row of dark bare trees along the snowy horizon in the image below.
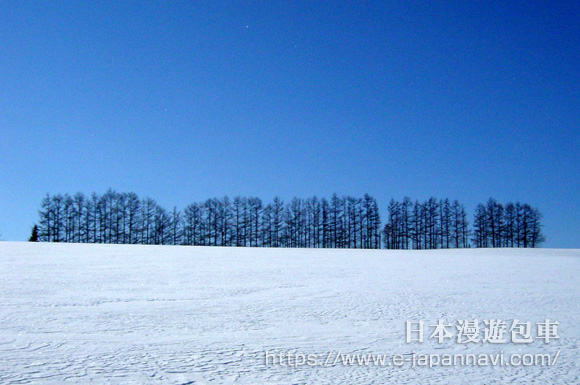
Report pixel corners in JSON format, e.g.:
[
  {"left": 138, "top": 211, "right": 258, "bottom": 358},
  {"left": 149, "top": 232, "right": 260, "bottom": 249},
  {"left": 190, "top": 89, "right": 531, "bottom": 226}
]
[{"left": 30, "top": 190, "right": 544, "bottom": 249}]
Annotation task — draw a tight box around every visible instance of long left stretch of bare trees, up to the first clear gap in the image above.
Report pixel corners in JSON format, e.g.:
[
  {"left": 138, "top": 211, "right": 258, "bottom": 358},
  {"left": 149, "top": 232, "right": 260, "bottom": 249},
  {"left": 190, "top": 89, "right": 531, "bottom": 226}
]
[{"left": 31, "top": 190, "right": 381, "bottom": 248}]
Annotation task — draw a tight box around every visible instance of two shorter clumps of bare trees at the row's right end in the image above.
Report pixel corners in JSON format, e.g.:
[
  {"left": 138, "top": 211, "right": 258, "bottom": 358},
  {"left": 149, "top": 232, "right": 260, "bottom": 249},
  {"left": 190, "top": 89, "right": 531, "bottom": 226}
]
[{"left": 383, "top": 197, "right": 545, "bottom": 249}]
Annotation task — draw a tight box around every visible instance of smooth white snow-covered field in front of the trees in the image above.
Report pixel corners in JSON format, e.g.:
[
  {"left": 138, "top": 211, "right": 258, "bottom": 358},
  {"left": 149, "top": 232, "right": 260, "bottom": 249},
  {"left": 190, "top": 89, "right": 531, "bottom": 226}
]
[{"left": 0, "top": 242, "right": 580, "bottom": 385}]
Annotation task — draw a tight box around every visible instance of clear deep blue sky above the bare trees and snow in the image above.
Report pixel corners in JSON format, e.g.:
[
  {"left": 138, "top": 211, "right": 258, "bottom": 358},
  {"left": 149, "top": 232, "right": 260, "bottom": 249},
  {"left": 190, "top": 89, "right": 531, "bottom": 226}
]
[{"left": 0, "top": 0, "right": 580, "bottom": 248}]
